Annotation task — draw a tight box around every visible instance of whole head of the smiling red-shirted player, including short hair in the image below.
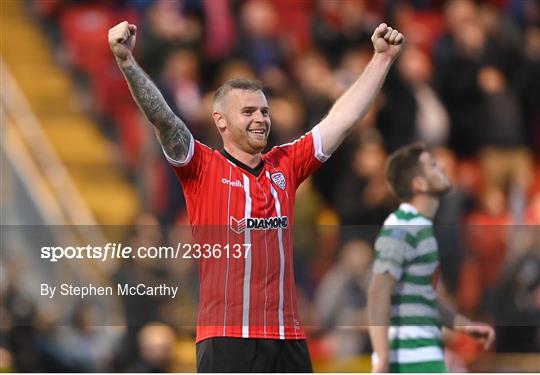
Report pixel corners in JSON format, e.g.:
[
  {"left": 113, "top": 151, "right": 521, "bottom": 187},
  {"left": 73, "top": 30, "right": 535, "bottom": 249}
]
[{"left": 212, "top": 78, "right": 271, "bottom": 154}]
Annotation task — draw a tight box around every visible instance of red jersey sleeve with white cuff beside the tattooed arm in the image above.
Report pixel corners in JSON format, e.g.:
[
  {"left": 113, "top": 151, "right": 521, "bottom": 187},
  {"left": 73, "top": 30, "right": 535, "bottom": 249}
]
[{"left": 162, "top": 136, "right": 212, "bottom": 194}]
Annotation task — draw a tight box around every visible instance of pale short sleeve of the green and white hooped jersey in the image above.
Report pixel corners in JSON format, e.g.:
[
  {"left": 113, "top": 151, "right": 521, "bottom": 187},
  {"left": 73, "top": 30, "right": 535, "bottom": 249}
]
[{"left": 373, "top": 226, "right": 407, "bottom": 281}]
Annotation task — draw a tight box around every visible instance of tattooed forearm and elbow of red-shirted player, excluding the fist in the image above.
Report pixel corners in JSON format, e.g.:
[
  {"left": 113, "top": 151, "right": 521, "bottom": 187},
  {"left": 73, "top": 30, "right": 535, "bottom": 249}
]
[{"left": 121, "top": 63, "right": 191, "bottom": 160}]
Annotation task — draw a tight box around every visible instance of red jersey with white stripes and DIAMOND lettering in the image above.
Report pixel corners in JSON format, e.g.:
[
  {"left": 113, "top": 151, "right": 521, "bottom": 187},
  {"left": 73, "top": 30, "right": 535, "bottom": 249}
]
[{"left": 167, "top": 127, "right": 328, "bottom": 342}]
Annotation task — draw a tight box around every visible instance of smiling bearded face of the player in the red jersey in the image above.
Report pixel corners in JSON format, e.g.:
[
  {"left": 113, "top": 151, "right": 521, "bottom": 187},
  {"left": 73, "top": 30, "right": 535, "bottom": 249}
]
[{"left": 223, "top": 90, "right": 271, "bottom": 154}]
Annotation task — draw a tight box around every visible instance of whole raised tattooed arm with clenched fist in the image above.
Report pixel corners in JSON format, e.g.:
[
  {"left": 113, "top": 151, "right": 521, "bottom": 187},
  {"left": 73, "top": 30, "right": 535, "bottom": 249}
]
[{"left": 109, "top": 21, "right": 191, "bottom": 161}]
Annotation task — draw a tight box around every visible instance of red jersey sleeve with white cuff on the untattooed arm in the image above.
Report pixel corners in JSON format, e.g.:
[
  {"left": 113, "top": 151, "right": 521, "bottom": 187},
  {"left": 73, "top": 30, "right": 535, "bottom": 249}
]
[{"left": 278, "top": 126, "right": 330, "bottom": 186}]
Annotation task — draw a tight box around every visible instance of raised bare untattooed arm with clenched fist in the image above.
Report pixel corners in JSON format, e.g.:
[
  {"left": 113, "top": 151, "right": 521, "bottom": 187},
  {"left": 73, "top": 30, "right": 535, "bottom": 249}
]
[{"left": 319, "top": 23, "right": 405, "bottom": 155}]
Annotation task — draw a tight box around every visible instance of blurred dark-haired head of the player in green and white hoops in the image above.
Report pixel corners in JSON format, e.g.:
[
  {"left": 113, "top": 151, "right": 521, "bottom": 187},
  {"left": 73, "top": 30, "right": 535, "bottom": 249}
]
[{"left": 386, "top": 143, "right": 452, "bottom": 202}]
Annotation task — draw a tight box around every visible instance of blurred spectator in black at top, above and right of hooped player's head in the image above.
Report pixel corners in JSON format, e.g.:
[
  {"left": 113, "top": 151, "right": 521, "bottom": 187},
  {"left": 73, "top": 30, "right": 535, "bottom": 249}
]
[{"left": 434, "top": 0, "right": 492, "bottom": 156}]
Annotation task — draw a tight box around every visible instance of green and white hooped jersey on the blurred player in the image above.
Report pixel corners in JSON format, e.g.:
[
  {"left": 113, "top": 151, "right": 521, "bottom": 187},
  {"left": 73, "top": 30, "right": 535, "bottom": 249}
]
[{"left": 373, "top": 203, "right": 447, "bottom": 372}]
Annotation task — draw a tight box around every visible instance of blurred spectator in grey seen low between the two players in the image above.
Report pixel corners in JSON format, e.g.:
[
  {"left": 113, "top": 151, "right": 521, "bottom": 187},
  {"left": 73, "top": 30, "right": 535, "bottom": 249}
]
[{"left": 313, "top": 240, "right": 373, "bottom": 358}]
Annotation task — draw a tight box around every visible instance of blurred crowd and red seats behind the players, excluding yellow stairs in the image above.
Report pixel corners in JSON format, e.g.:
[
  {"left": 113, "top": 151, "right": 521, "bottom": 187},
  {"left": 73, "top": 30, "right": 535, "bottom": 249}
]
[{"left": 0, "top": 0, "right": 540, "bottom": 371}]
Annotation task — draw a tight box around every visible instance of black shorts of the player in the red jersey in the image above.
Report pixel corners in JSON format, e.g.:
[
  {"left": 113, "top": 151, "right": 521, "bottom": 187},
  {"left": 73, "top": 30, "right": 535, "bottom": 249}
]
[{"left": 197, "top": 337, "right": 313, "bottom": 372}]
